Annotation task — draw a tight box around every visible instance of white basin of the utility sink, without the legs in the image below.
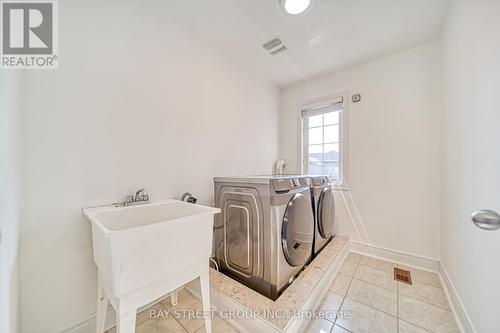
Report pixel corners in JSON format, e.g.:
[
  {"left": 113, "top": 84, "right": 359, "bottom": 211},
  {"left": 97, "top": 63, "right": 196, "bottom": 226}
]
[{"left": 83, "top": 199, "right": 220, "bottom": 297}]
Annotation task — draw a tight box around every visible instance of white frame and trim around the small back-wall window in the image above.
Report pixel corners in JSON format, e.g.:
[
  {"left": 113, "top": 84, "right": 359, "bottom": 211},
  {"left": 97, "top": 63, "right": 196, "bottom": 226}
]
[{"left": 299, "top": 92, "right": 348, "bottom": 190}]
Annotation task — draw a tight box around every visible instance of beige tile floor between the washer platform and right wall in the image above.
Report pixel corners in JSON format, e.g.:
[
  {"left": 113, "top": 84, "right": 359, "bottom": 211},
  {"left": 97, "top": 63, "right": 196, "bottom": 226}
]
[{"left": 306, "top": 253, "right": 459, "bottom": 333}]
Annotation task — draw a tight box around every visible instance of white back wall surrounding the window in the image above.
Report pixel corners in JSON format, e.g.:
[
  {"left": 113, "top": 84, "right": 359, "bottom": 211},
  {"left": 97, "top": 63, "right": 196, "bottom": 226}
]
[{"left": 280, "top": 42, "right": 441, "bottom": 259}]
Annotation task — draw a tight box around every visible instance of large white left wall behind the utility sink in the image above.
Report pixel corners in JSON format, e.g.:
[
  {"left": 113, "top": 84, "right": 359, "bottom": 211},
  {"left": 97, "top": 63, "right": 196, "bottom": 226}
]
[{"left": 16, "top": 0, "right": 279, "bottom": 333}]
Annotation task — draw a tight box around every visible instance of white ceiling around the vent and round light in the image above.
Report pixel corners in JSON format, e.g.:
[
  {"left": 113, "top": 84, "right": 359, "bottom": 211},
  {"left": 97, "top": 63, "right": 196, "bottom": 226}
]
[{"left": 166, "top": 0, "right": 451, "bottom": 87}]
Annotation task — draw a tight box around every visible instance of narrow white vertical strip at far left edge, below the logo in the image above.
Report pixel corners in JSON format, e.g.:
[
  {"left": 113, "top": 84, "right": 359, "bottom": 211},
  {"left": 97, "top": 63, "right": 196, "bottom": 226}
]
[{"left": 0, "top": 71, "right": 19, "bottom": 333}]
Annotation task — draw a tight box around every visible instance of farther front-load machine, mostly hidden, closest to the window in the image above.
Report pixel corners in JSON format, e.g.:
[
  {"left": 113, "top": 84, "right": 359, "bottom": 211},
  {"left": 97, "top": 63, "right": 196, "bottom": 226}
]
[{"left": 310, "top": 176, "right": 335, "bottom": 257}]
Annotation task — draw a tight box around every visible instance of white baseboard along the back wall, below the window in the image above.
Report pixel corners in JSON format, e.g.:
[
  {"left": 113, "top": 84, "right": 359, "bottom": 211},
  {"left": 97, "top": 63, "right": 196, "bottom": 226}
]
[{"left": 349, "top": 240, "right": 439, "bottom": 272}]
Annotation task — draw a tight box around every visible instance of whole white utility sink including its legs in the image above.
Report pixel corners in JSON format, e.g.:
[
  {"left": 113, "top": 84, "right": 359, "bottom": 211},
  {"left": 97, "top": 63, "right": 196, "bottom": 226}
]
[{"left": 83, "top": 199, "right": 220, "bottom": 333}]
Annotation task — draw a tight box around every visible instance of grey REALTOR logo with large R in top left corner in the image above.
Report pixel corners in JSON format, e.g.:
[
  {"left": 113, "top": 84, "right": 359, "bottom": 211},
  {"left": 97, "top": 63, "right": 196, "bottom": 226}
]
[{"left": 1, "top": 0, "right": 57, "bottom": 69}]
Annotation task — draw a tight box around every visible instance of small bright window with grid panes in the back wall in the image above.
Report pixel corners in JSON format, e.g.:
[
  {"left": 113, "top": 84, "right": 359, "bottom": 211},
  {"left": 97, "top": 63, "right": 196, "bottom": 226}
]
[{"left": 302, "top": 97, "right": 344, "bottom": 184}]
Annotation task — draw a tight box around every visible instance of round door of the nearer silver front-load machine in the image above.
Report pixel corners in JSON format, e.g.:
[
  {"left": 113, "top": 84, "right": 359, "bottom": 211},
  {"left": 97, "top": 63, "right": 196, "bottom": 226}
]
[{"left": 281, "top": 193, "right": 314, "bottom": 267}]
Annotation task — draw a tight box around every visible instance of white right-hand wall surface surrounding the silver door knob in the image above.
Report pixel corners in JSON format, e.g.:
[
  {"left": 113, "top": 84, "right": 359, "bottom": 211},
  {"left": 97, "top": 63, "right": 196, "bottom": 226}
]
[{"left": 441, "top": 0, "right": 500, "bottom": 333}]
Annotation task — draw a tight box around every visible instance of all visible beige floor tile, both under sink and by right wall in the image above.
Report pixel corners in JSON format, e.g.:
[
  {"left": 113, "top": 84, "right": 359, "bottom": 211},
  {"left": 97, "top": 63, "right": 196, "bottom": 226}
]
[{"left": 108, "top": 253, "right": 459, "bottom": 333}]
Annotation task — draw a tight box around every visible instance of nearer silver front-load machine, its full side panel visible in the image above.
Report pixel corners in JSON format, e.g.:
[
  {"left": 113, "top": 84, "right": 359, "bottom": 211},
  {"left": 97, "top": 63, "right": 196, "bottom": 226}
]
[{"left": 214, "top": 176, "right": 314, "bottom": 300}]
